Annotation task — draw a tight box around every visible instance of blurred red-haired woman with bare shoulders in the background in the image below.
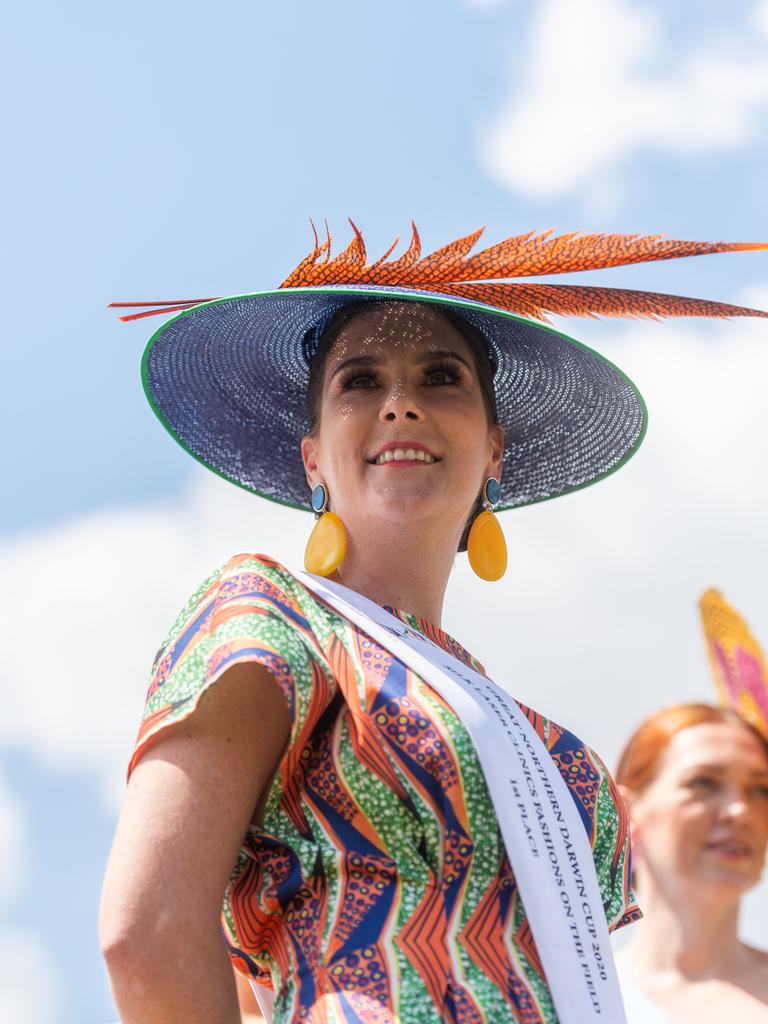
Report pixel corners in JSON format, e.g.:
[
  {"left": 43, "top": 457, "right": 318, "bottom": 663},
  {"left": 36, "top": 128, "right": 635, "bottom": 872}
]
[{"left": 616, "top": 705, "right": 768, "bottom": 1024}]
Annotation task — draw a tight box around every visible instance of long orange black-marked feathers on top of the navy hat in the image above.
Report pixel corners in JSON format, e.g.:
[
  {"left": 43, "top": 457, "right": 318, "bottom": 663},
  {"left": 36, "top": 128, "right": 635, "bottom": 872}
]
[{"left": 111, "top": 220, "right": 768, "bottom": 322}]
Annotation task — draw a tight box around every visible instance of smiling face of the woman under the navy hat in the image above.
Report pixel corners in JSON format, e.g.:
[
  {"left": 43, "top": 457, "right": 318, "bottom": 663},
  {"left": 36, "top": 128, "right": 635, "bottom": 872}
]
[{"left": 302, "top": 303, "right": 503, "bottom": 545}]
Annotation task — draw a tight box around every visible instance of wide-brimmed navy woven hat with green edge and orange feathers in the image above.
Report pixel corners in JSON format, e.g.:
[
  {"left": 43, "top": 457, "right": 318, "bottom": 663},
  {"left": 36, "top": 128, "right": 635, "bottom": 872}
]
[{"left": 118, "top": 223, "right": 765, "bottom": 510}]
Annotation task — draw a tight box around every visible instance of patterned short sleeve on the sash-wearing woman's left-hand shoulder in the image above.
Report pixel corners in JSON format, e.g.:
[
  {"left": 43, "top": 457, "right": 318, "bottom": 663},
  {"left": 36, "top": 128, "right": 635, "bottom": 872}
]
[{"left": 128, "top": 555, "right": 333, "bottom": 776}]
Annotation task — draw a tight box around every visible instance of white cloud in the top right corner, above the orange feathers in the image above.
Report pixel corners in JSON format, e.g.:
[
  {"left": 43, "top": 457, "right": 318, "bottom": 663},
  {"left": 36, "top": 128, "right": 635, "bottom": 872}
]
[{"left": 480, "top": 0, "right": 768, "bottom": 204}]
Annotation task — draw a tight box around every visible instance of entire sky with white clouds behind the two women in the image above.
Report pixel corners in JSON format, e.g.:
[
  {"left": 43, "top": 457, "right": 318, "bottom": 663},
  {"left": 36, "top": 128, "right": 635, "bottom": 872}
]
[{"left": 0, "top": 0, "right": 768, "bottom": 1024}]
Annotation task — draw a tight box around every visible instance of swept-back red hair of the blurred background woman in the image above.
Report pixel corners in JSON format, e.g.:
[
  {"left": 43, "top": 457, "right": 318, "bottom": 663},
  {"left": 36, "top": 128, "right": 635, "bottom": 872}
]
[{"left": 615, "top": 703, "right": 768, "bottom": 793}]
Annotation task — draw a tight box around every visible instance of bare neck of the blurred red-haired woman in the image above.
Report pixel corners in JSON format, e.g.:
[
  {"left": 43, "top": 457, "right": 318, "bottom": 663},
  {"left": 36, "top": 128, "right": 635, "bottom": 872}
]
[{"left": 628, "top": 880, "right": 745, "bottom": 981}]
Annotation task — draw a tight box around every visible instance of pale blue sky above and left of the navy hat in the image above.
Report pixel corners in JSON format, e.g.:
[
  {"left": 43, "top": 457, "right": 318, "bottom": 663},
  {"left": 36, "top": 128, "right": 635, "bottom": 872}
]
[{"left": 0, "top": 0, "right": 768, "bottom": 531}]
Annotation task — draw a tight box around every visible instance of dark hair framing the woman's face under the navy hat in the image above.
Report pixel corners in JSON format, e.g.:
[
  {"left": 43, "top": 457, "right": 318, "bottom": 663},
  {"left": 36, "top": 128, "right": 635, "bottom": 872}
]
[{"left": 304, "top": 299, "right": 499, "bottom": 551}]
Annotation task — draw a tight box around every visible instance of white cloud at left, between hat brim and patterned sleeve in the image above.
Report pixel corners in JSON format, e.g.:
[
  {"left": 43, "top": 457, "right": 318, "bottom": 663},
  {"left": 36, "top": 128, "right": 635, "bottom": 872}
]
[{"left": 0, "top": 483, "right": 307, "bottom": 806}]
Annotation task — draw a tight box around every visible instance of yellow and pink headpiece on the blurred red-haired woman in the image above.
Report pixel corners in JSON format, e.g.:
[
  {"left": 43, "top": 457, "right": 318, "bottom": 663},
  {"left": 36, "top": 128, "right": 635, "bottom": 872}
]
[{"left": 699, "top": 590, "right": 768, "bottom": 738}]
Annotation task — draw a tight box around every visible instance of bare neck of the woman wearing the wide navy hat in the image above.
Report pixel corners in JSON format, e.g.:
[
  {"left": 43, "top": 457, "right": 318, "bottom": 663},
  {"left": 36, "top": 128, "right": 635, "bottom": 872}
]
[{"left": 334, "top": 512, "right": 456, "bottom": 626}]
